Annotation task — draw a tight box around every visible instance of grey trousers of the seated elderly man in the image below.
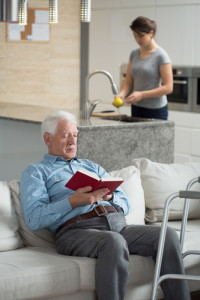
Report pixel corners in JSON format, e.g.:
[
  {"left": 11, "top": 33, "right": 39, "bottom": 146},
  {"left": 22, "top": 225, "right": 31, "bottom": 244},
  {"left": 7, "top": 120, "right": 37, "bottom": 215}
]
[{"left": 56, "top": 213, "right": 190, "bottom": 300}]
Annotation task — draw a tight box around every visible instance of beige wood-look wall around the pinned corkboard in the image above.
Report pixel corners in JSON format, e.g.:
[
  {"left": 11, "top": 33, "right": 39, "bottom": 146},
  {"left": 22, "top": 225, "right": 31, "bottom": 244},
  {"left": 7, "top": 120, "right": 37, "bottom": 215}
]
[{"left": 0, "top": 0, "right": 80, "bottom": 109}]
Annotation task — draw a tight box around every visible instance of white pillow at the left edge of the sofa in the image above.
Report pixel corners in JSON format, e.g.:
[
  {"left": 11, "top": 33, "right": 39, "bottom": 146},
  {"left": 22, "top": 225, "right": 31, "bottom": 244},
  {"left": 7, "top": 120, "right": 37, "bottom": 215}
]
[{"left": 0, "top": 181, "right": 23, "bottom": 251}]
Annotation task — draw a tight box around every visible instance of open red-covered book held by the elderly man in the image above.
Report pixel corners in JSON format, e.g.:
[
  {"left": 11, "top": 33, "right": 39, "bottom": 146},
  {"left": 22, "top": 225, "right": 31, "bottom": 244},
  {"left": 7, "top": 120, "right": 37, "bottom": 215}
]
[{"left": 65, "top": 169, "right": 123, "bottom": 194}]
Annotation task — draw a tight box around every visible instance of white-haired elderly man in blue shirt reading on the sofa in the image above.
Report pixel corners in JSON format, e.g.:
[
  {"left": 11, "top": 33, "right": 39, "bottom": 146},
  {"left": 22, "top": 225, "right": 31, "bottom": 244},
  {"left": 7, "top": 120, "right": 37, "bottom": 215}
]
[{"left": 20, "top": 111, "right": 190, "bottom": 300}]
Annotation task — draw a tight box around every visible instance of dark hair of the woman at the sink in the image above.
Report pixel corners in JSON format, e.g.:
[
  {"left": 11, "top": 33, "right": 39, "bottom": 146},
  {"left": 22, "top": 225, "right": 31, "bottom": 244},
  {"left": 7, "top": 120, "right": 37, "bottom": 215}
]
[{"left": 130, "top": 17, "right": 157, "bottom": 35}]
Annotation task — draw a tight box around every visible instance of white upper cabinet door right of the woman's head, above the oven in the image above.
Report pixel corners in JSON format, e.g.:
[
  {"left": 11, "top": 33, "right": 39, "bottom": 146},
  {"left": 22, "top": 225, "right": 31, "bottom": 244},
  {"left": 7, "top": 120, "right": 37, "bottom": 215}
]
[{"left": 156, "top": 5, "right": 195, "bottom": 65}]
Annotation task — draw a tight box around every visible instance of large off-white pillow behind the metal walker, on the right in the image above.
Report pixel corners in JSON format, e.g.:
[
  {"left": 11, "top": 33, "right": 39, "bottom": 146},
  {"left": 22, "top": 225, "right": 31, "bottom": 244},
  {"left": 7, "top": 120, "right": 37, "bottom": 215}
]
[{"left": 133, "top": 158, "right": 200, "bottom": 222}]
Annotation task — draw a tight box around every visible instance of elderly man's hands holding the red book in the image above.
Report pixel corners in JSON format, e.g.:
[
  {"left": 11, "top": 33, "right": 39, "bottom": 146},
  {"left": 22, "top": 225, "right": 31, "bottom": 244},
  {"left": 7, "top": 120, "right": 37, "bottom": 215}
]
[{"left": 69, "top": 186, "right": 112, "bottom": 208}]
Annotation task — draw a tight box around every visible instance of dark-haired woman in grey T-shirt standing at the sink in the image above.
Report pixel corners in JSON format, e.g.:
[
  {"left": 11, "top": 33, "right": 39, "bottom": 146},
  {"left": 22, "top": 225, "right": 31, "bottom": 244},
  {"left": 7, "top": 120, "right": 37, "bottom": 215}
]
[{"left": 117, "top": 17, "right": 173, "bottom": 120}]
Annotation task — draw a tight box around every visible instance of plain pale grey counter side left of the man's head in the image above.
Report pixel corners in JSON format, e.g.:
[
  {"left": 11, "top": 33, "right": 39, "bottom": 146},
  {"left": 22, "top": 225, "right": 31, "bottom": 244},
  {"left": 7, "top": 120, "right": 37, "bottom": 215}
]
[{"left": 0, "top": 119, "right": 47, "bottom": 181}]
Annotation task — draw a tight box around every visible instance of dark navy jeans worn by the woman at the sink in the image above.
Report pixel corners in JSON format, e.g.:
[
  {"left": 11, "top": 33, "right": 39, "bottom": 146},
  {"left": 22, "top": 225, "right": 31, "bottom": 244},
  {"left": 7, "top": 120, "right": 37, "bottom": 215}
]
[{"left": 131, "top": 105, "right": 168, "bottom": 120}]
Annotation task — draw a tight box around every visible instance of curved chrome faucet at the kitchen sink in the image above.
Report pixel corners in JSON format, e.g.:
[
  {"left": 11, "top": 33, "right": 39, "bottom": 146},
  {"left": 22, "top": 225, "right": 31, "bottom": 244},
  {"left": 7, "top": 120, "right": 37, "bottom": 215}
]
[{"left": 85, "top": 70, "right": 119, "bottom": 120}]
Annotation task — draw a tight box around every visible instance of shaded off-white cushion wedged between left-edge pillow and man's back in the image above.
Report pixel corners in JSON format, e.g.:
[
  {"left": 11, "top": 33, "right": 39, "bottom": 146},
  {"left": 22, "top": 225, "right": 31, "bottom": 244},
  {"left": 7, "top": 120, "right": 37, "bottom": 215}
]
[{"left": 9, "top": 180, "right": 55, "bottom": 247}]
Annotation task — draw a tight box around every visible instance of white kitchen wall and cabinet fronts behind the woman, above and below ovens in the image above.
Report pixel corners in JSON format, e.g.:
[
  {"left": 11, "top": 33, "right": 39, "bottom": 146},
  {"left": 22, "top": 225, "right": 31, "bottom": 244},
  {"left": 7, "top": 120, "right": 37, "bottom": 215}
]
[{"left": 89, "top": 0, "right": 200, "bottom": 162}]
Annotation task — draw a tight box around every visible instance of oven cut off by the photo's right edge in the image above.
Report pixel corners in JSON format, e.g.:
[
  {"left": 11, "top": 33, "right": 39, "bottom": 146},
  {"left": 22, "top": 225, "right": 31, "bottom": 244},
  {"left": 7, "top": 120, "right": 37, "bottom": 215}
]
[{"left": 192, "top": 67, "right": 200, "bottom": 113}]
